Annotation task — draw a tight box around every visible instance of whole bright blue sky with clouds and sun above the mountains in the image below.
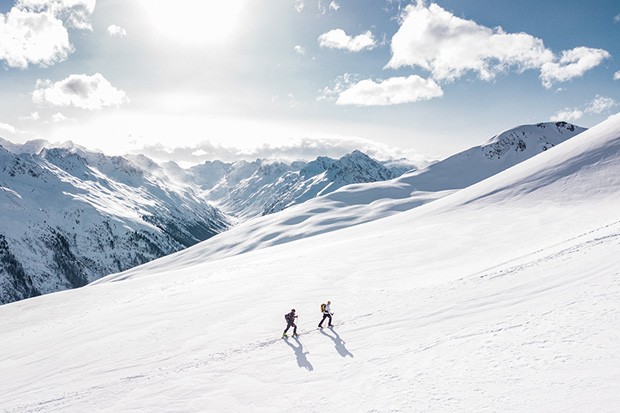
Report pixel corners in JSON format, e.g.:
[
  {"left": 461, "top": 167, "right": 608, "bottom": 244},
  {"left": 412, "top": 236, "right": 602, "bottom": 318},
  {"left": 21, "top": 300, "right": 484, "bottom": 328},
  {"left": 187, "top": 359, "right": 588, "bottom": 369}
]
[{"left": 0, "top": 0, "right": 620, "bottom": 164}]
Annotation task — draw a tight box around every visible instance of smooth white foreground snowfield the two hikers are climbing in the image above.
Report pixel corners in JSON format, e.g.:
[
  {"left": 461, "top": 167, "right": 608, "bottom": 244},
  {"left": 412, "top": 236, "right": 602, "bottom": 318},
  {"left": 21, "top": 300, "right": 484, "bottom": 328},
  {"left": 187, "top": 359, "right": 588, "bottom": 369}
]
[{"left": 0, "top": 115, "right": 620, "bottom": 412}]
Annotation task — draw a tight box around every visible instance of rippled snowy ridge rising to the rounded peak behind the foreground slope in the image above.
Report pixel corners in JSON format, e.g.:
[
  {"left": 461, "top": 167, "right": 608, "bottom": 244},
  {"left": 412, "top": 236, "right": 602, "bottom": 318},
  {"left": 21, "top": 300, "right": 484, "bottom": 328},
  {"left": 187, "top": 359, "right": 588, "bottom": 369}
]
[{"left": 137, "top": 122, "right": 585, "bottom": 260}]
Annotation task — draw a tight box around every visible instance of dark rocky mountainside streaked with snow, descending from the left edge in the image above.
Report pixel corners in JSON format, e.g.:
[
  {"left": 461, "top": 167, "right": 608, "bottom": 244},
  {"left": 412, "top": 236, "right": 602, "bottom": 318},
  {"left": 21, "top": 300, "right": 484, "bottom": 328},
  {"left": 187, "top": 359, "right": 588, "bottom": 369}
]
[{"left": 0, "top": 141, "right": 228, "bottom": 304}]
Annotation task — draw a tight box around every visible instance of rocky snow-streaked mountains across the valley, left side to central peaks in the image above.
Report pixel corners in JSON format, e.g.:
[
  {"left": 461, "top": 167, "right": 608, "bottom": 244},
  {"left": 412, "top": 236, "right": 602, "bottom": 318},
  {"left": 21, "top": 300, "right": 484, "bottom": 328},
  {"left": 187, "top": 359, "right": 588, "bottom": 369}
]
[{"left": 0, "top": 140, "right": 411, "bottom": 304}]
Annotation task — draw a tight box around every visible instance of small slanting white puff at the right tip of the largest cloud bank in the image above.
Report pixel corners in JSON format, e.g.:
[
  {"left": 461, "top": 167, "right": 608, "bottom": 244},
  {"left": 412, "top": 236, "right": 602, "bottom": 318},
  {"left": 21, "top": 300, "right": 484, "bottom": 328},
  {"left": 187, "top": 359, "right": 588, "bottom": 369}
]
[{"left": 540, "top": 47, "right": 611, "bottom": 89}]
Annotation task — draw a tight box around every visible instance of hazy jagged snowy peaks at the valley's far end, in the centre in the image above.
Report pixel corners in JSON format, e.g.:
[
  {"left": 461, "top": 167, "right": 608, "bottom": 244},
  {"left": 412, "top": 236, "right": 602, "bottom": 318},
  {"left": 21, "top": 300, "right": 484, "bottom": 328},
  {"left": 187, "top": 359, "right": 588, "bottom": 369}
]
[{"left": 176, "top": 151, "right": 416, "bottom": 219}]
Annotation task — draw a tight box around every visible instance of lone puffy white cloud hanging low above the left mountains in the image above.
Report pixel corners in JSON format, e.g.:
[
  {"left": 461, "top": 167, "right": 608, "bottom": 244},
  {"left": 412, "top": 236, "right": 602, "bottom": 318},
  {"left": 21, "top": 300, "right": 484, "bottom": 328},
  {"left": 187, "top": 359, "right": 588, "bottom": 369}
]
[{"left": 32, "top": 73, "right": 128, "bottom": 110}]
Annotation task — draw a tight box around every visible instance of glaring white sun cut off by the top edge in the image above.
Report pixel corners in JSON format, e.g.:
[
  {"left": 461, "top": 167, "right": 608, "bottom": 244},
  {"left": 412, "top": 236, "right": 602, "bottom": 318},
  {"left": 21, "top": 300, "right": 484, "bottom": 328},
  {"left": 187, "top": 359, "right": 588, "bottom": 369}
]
[{"left": 141, "top": 0, "right": 247, "bottom": 45}]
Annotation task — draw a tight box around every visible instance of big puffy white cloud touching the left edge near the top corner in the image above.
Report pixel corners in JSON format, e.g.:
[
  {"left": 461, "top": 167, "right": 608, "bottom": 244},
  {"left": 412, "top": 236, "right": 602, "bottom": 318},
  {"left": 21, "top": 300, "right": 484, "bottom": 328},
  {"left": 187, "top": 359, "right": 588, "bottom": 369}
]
[{"left": 0, "top": 7, "right": 73, "bottom": 69}]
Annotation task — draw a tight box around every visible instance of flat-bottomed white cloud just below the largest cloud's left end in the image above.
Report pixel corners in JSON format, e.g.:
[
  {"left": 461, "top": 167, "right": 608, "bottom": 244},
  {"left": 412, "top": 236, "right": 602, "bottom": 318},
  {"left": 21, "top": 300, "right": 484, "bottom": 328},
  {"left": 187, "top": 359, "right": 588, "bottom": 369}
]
[{"left": 336, "top": 75, "right": 443, "bottom": 106}]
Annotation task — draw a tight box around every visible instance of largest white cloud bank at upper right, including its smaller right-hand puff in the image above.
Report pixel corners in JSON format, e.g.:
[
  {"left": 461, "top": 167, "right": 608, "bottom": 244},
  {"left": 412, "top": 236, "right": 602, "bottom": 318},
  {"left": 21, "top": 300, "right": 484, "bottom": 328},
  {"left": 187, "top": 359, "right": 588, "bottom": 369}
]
[{"left": 386, "top": 0, "right": 610, "bottom": 87}]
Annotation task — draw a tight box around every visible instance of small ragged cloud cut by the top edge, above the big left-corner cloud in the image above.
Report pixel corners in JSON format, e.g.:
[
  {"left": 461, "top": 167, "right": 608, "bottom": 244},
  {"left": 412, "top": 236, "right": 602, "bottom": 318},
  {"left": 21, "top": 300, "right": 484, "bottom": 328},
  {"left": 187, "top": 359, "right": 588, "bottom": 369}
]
[{"left": 15, "top": 0, "right": 96, "bottom": 30}]
